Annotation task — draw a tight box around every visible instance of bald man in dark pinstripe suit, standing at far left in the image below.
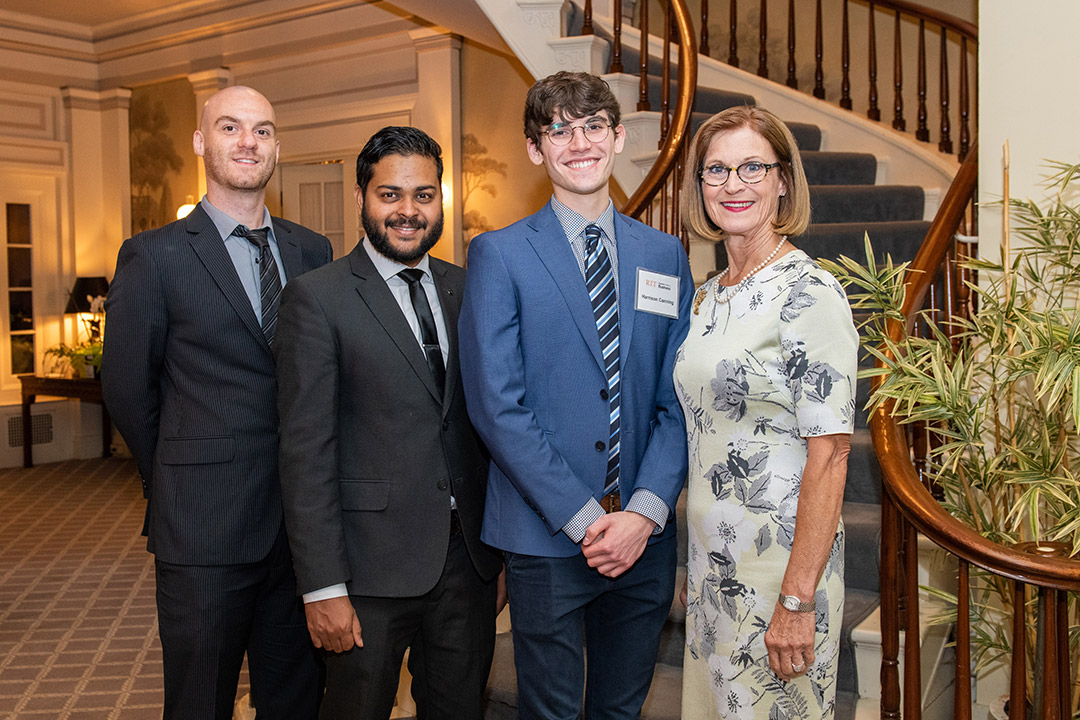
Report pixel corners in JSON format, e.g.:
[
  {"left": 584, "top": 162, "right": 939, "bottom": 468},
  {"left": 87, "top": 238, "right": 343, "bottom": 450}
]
[{"left": 102, "top": 86, "right": 332, "bottom": 720}]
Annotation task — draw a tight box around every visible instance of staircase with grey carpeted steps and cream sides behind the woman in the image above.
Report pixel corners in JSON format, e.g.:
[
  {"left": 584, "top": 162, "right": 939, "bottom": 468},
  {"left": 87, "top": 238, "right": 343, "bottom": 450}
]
[{"left": 477, "top": 0, "right": 958, "bottom": 720}]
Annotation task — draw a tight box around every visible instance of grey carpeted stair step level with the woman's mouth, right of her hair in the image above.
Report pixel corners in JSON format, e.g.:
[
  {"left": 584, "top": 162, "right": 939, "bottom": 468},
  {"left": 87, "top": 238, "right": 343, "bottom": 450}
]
[{"left": 810, "top": 185, "right": 926, "bottom": 222}]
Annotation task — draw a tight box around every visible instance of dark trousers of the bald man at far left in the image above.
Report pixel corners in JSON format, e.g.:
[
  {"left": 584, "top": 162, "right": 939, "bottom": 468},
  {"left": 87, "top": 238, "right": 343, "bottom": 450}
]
[{"left": 156, "top": 530, "right": 321, "bottom": 720}]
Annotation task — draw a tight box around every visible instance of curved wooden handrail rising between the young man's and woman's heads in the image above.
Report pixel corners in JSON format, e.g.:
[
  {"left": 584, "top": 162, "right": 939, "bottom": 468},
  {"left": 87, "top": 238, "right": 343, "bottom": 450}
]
[{"left": 622, "top": 0, "right": 698, "bottom": 217}]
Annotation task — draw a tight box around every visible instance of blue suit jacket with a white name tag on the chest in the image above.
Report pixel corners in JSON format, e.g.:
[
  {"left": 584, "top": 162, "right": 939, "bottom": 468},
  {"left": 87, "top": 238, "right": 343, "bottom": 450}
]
[{"left": 458, "top": 205, "right": 693, "bottom": 557}]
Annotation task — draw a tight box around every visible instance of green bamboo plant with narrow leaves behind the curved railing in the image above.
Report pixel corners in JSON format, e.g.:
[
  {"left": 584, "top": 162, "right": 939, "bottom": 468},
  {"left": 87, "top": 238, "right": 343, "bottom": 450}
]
[{"left": 822, "top": 163, "right": 1080, "bottom": 717}]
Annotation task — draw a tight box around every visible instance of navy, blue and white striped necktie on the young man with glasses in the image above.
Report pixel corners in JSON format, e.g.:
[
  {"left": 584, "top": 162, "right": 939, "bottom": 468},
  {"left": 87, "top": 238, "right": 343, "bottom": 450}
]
[{"left": 585, "top": 225, "right": 620, "bottom": 497}]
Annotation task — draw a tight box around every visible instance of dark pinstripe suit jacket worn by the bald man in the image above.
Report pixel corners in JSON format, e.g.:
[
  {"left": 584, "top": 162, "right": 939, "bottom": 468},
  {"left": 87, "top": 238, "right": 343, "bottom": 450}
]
[{"left": 102, "top": 206, "right": 332, "bottom": 565}]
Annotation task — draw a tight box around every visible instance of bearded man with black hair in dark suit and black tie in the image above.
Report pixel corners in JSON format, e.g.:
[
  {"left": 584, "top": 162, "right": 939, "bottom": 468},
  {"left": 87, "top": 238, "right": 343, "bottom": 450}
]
[{"left": 276, "top": 127, "right": 501, "bottom": 720}]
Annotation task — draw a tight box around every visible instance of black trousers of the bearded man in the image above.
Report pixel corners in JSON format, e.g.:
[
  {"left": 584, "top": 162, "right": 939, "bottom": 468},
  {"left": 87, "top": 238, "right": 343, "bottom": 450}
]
[{"left": 319, "top": 533, "right": 496, "bottom": 720}]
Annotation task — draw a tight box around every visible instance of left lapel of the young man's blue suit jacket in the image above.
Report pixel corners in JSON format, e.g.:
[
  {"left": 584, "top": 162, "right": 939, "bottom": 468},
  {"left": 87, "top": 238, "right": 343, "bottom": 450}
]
[{"left": 527, "top": 205, "right": 604, "bottom": 369}]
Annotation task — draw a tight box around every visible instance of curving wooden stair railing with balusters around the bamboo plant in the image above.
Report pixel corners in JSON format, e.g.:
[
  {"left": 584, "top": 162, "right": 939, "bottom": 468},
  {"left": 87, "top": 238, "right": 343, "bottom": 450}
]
[{"left": 870, "top": 146, "right": 1080, "bottom": 720}]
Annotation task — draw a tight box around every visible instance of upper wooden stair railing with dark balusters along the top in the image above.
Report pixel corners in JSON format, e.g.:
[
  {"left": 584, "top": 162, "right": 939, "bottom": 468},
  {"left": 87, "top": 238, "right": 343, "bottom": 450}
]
[{"left": 582, "top": 0, "right": 978, "bottom": 162}]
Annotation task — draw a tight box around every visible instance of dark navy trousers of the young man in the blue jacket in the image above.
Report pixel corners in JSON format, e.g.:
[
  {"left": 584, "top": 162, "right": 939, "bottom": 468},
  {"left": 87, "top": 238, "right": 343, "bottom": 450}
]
[{"left": 507, "top": 533, "right": 676, "bottom": 720}]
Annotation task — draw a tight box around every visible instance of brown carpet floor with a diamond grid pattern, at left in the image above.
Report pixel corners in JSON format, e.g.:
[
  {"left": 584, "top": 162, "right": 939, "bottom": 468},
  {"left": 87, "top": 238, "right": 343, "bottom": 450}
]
[{"left": 0, "top": 459, "right": 247, "bottom": 720}]
